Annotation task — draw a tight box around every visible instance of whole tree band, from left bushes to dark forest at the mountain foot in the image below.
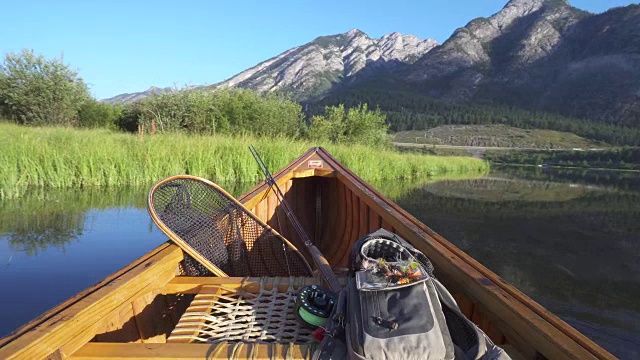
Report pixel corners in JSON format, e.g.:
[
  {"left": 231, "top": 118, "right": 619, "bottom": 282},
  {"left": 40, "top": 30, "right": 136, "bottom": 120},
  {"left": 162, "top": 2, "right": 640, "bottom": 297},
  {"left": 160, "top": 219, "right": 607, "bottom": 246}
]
[{"left": 5, "top": 50, "right": 640, "bottom": 146}]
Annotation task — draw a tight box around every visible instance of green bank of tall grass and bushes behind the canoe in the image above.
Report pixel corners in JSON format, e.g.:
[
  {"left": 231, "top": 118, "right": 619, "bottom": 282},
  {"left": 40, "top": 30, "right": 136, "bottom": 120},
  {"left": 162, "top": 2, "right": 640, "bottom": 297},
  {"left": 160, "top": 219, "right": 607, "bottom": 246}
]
[{"left": 0, "top": 51, "right": 488, "bottom": 198}]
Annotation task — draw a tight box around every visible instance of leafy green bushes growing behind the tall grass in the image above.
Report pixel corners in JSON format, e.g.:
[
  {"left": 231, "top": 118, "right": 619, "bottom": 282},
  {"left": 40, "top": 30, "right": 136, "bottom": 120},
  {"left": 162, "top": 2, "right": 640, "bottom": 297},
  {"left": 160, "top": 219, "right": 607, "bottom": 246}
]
[{"left": 0, "top": 50, "right": 389, "bottom": 143}]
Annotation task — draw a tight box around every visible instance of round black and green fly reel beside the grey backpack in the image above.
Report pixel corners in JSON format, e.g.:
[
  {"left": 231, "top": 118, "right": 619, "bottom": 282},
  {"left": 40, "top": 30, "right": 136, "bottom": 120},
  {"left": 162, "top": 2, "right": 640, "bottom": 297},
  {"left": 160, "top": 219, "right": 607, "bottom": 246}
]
[{"left": 295, "top": 285, "right": 338, "bottom": 329}]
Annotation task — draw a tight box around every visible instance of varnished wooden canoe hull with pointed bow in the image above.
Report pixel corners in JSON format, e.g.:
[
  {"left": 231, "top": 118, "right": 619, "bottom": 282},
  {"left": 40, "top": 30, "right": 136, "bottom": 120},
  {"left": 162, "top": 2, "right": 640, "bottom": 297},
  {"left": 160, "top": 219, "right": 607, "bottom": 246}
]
[{"left": 0, "top": 148, "right": 615, "bottom": 360}]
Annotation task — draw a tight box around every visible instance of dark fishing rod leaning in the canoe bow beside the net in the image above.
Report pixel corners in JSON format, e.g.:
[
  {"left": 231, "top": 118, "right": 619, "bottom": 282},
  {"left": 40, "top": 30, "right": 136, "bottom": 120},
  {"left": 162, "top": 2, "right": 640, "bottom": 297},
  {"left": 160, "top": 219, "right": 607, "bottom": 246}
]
[{"left": 249, "top": 145, "right": 342, "bottom": 293}]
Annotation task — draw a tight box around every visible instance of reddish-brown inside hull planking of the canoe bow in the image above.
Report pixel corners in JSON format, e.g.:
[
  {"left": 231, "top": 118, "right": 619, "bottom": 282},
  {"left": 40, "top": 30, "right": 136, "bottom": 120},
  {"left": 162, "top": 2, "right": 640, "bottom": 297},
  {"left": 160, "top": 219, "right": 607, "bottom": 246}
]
[{"left": 246, "top": 175, "right": 537, "bottom": 359}]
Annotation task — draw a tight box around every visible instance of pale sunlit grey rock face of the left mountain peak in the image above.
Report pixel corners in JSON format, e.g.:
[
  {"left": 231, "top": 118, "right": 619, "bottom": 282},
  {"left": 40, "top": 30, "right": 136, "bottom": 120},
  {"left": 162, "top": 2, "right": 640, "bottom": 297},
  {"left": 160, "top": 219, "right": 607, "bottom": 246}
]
[{"left": 215, "top": 29, "right": 438, "bottom": 99}]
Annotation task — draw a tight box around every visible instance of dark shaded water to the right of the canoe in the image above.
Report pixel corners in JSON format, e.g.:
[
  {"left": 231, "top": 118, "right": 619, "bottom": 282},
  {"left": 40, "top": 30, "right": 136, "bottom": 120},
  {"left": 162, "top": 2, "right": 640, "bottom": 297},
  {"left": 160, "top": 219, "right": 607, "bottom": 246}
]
[{"left": 395, "top": 168, "right": 640, "bottom": 359}]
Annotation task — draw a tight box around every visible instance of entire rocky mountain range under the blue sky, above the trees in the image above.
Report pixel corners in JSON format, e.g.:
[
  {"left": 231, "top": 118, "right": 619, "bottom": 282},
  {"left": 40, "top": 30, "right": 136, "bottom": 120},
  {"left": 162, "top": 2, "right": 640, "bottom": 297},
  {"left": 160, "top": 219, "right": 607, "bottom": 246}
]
[{"left": 105, "top": 0, "right": 640, "bottom": 126}]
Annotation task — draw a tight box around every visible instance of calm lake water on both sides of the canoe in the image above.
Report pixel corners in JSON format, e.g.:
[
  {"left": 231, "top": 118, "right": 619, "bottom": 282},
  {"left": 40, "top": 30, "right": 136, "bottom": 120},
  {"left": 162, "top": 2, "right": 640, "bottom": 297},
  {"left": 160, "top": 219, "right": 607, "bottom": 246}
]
[{"left": 0, "top": 168, "right": 640, "bottom": 358}]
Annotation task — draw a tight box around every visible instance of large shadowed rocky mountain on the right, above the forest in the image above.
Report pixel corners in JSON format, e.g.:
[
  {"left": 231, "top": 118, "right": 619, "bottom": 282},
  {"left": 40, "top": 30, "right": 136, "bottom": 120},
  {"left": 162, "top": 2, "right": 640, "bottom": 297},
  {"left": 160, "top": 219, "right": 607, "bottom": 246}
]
[{"left": 396, "top": 0, "right": 640, "bottom": 125}]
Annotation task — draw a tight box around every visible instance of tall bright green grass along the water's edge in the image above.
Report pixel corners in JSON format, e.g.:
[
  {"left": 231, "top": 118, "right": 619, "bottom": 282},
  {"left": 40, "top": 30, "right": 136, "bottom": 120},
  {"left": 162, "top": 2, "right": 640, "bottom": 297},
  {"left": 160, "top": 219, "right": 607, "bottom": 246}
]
[{"left": 0, "top": 123, "right": 489, "bottom": 198}]
